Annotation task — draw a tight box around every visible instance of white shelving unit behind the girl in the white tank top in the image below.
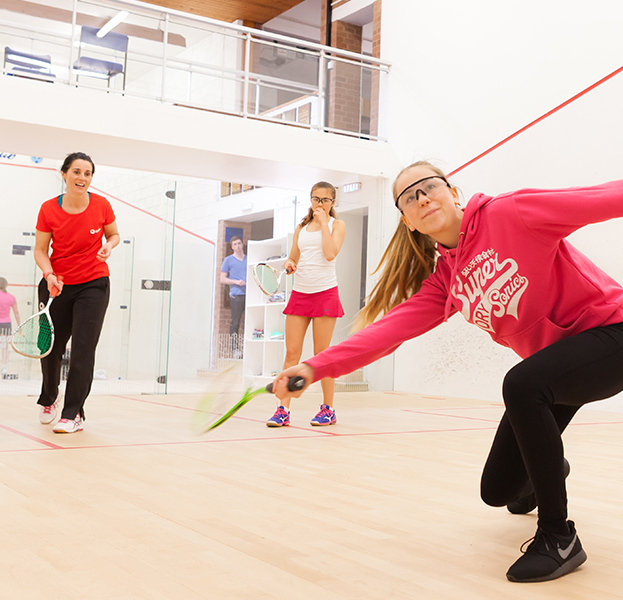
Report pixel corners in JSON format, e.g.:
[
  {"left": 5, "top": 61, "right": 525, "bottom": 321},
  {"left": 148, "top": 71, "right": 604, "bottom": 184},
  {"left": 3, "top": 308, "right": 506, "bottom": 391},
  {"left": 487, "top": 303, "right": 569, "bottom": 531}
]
[{"left": 243, "top": 234, "right": 293, "bottom": 386}]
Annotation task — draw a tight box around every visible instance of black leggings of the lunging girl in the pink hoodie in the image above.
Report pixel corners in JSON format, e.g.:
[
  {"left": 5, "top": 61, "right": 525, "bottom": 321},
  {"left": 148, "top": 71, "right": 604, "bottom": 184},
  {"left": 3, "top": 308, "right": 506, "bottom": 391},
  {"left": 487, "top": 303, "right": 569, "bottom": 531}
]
[{"left": 481, "top": 323, "right": 623, "bottom": 531}]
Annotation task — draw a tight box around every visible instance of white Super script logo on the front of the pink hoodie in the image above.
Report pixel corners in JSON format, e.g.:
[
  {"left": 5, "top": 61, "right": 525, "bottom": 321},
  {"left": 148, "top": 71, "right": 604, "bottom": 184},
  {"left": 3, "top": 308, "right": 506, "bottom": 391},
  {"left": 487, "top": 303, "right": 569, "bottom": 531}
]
[{"left": 452, "top": 252, "right": 529, "bottom": 333}]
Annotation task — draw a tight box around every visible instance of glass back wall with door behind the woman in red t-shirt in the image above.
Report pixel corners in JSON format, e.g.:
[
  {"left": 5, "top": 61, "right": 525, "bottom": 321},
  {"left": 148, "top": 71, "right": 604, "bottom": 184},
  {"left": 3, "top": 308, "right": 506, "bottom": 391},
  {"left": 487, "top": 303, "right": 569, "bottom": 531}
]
[{"left": 0, "top": 154, "right": 217, "bottom": 395}]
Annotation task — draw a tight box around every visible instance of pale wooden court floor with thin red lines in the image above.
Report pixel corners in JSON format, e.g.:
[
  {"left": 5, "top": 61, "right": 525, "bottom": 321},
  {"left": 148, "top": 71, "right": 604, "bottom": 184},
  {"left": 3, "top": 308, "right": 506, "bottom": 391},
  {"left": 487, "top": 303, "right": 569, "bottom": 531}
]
[{"left": 0, "top": 392, "right": 623, "bottom": 600}]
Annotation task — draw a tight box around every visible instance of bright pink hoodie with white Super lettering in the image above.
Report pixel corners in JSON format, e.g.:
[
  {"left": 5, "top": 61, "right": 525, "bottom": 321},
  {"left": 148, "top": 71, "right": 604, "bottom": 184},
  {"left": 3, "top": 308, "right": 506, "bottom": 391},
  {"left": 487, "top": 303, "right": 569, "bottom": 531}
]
[{"left": 305, "top": 181, "right": 623, "bottom": 381}]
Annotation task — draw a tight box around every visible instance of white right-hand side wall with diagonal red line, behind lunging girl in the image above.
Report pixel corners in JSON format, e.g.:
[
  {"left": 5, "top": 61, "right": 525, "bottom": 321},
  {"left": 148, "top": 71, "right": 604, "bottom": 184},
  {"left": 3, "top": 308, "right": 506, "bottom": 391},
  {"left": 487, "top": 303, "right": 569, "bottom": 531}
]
[{"left": 382, "top": 0, "right": 623, "bottom": 400}]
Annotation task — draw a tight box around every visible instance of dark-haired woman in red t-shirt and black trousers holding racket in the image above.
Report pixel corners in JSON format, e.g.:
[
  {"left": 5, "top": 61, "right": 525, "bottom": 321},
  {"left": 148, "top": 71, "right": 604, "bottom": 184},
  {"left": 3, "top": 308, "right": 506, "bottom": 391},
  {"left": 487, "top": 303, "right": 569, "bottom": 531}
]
[{"left": 34, "top": 152, "right": 120, "bottom": 433}]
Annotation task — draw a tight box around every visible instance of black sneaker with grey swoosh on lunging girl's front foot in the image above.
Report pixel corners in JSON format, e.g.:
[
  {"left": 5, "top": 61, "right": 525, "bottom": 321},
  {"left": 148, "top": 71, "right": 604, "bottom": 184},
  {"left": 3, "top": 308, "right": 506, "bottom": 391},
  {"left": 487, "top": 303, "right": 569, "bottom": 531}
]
[{"left": 506, "top": 521, "right": 586, "bottom": 583}]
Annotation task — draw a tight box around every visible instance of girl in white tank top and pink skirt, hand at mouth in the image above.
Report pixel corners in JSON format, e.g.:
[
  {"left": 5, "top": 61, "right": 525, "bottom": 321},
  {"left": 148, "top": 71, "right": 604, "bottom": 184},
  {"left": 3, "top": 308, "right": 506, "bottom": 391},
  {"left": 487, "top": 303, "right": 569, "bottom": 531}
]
[{"left": 266, "top": 181, "right": 346, "bottom": 427}]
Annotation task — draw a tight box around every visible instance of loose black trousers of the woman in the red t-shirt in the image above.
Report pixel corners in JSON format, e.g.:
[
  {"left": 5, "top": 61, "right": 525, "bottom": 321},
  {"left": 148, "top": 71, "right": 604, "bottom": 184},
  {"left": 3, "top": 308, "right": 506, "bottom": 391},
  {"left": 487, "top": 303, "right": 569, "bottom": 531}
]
[{"left": 38, "top": 277, "right": 110, "bottom": 419}]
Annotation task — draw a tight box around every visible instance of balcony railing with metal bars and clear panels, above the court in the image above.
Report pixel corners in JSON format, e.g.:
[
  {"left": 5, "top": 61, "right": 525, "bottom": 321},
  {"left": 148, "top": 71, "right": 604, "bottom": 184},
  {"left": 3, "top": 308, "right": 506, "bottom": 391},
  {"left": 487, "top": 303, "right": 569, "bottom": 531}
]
[{"left": 0, "top": 0, "right": 389, "bottom": 140}]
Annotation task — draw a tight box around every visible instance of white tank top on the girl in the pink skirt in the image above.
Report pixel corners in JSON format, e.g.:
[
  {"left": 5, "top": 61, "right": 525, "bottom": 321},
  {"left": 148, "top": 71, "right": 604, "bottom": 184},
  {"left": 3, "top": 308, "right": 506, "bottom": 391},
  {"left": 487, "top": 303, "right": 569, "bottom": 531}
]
[{"left": 292, "top": 217, "right": 337, "bottom": 294}]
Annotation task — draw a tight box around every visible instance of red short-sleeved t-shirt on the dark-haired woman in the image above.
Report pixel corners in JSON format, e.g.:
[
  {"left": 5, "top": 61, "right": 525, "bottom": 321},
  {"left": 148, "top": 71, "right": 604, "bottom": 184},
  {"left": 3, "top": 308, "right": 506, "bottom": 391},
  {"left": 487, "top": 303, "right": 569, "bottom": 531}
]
[{"left": 37, "top": 192, "right": 115, "bottom": 285}]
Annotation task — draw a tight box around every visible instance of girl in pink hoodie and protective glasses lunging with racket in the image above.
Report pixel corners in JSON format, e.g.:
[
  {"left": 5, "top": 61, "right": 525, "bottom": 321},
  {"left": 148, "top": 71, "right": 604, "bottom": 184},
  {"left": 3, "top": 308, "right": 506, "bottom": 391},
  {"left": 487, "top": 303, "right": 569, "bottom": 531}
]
[{"left": 275, "top": 162, "right": 623, "bottom": 582}]
